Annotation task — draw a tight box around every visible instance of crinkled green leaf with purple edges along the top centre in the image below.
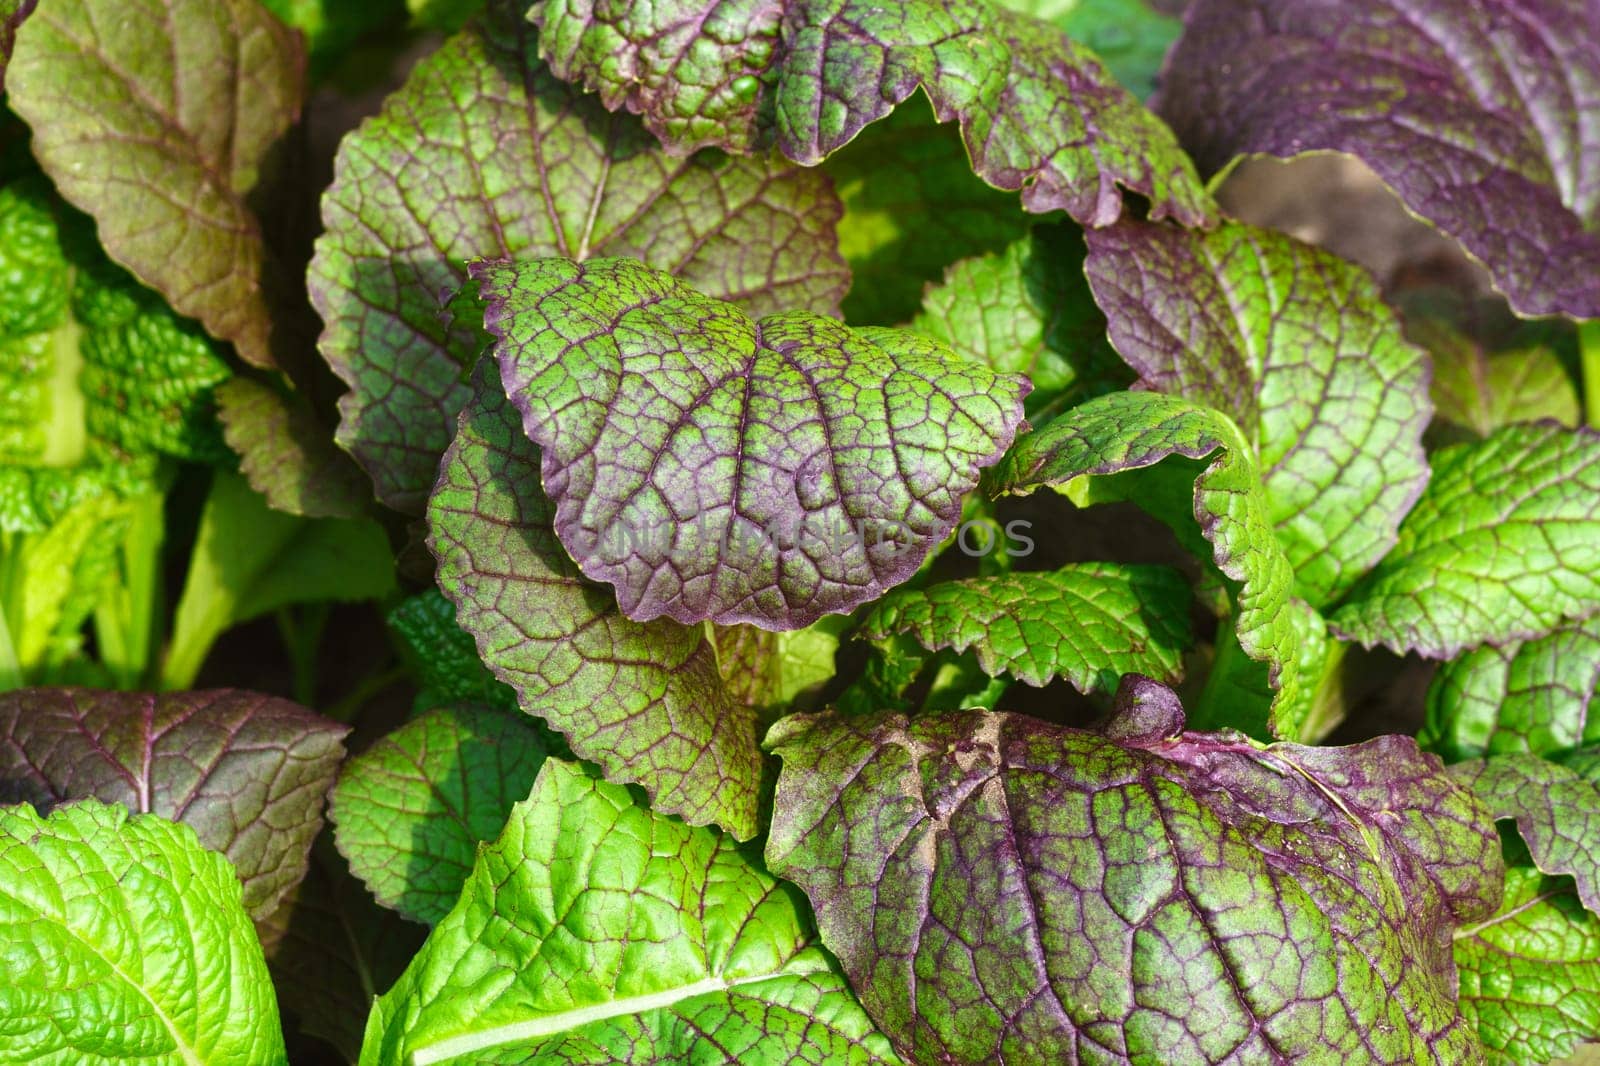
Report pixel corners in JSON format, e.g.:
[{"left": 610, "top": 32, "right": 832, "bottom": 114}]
[{"left": 530, "top": 0, "right": 1213, "bottom": 226}]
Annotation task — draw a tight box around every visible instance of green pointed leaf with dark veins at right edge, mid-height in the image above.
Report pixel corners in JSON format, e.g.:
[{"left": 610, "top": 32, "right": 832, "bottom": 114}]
[{"left": 1330, "top": 423, "right": 1600, "bottom": 659}]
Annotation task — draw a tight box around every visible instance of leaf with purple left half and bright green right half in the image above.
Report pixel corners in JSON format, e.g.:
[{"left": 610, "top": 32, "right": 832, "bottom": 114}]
[{"left": 1086, "top": 222, "right": 1430, "bottom": 607}]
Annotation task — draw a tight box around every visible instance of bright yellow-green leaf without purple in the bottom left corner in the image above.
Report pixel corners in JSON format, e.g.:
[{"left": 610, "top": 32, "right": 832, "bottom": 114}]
[{"left": 0, "top": 800, "right": 288, "bottom": 1066}]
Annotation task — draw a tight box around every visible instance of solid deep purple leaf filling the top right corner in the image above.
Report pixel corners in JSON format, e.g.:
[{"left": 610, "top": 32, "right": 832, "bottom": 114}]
[{"left": 1158, "top": 0, "right": 1600, "bottom": 319}]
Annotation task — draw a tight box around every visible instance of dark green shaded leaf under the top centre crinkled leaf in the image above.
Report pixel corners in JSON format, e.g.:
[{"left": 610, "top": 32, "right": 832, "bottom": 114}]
[{"left": 822, "top": 101, "right": 1032, "bottom": 325}]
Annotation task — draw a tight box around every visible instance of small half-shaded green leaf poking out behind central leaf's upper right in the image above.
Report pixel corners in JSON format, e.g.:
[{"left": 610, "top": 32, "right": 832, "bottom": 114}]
[{"left": 912, "top": 226, "right": 1131, "bottom": 416}]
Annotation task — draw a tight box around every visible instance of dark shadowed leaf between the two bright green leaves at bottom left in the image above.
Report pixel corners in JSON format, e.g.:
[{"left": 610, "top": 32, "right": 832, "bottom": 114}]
[{"left": 256, "top": 836, "right": 427, "bottom": 1063}]
